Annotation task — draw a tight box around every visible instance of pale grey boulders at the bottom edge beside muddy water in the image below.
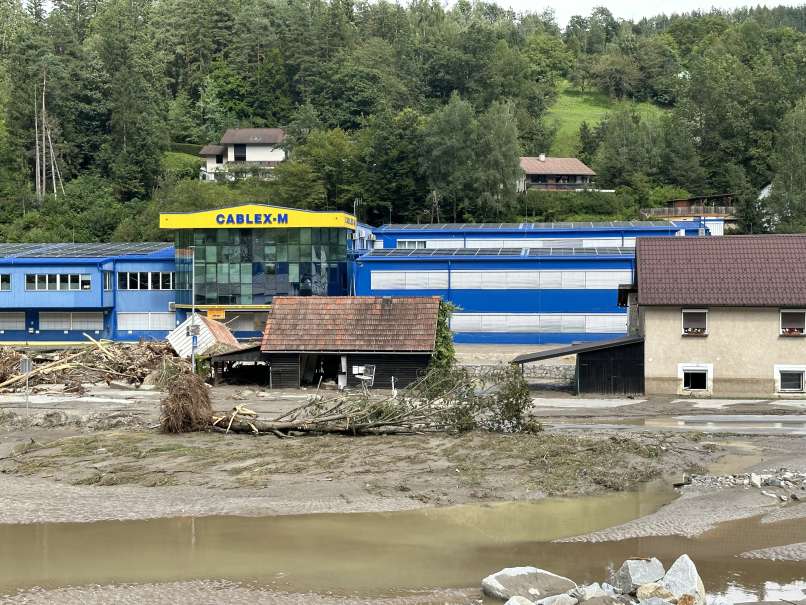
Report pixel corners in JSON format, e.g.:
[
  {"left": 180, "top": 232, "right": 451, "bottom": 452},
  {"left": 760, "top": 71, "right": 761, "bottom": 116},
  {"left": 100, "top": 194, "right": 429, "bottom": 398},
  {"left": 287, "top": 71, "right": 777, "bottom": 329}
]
[{"left": 481, "top": 555, "right": 705, "bottom": 605}]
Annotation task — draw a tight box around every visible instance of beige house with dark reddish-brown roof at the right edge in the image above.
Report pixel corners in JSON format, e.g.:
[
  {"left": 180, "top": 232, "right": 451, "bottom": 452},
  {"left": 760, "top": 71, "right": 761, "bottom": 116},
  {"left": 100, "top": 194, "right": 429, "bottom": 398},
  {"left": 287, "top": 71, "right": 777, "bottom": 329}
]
[{"left": 632, "top": 235, "right": 806, "bottom": 398}]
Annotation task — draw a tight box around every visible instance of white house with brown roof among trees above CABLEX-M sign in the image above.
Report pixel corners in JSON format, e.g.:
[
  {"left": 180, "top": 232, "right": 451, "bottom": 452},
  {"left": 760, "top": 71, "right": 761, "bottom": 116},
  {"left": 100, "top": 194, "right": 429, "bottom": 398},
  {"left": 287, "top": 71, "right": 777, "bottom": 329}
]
[{"left": 199, "top": 128, "right": 286, "bottom": 181}]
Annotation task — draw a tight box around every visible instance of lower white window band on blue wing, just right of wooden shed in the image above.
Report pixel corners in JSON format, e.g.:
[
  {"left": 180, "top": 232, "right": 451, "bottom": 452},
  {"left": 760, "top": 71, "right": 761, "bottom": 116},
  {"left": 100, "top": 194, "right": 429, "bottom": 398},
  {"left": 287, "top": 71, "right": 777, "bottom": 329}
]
[{"left": 451, "top": 313, "right": 627, "bottom": 334}]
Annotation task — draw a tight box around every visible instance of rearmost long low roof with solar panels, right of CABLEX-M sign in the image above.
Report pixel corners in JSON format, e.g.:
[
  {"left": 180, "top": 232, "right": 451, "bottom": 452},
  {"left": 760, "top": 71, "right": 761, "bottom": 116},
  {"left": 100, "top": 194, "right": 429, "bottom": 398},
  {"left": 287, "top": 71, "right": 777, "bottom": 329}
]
[{"left": 375, "top": 221, "right": 678, "bottom": 233}]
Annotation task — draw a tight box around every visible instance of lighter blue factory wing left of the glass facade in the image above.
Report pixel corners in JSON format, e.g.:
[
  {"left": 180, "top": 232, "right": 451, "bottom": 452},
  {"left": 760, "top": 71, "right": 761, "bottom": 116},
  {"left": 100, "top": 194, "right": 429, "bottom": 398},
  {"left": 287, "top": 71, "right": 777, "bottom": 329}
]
[{"left": 0, "top": 242, "right": 176, "bottom": 345}]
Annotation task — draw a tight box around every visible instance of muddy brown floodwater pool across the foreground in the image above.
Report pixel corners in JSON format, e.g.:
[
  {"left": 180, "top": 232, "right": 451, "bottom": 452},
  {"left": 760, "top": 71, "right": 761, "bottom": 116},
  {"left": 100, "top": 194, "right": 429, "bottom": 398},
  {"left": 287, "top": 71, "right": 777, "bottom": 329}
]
[{"left": 0, "top": 484, "right": 806, "bottom": 597}]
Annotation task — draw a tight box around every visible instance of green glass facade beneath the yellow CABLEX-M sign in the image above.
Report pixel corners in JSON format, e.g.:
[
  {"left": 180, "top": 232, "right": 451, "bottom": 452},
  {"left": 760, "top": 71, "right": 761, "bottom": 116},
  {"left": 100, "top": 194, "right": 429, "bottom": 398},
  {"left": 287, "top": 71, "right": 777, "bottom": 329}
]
[{"left": 176, "top": 227, "right": 350, "bottom": 305}]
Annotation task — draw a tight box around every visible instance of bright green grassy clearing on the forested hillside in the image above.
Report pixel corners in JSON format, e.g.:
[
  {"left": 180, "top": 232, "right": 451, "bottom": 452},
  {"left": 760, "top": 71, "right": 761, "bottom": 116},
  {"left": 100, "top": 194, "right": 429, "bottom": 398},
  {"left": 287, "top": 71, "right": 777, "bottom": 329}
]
[{"left": 548, "top": 81, "right": 664, "bottom": 157}]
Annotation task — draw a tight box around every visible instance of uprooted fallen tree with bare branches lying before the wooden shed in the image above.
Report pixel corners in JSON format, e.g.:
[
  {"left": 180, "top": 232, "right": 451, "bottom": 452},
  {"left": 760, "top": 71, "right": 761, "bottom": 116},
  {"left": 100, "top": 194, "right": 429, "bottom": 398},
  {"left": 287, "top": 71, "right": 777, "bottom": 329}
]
[{"left": 205, "top": 360, "right": 540, "bottom": 437}]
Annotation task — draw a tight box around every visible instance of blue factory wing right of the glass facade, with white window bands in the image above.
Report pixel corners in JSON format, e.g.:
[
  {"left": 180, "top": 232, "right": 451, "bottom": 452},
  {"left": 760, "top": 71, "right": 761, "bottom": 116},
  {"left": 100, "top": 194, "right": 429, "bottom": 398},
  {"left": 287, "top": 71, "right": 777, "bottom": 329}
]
[{"left": 356, "top": 221, "right": 708, "bottom": 344}]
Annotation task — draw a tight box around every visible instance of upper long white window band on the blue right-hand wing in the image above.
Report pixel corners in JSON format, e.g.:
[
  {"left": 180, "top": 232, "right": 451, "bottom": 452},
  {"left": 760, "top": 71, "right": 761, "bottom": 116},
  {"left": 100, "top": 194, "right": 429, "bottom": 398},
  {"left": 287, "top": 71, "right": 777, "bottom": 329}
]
[{"left": 370, "top": 269, "right": 632, "bottom": 290}]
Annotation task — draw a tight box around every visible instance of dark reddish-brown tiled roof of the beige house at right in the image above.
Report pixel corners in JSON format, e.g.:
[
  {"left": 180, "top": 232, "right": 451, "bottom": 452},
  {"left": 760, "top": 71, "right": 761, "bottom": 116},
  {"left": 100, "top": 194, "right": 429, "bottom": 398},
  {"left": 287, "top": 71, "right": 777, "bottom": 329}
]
[{"left": 636, "top": 235, "right": 806, "bottom": 307}]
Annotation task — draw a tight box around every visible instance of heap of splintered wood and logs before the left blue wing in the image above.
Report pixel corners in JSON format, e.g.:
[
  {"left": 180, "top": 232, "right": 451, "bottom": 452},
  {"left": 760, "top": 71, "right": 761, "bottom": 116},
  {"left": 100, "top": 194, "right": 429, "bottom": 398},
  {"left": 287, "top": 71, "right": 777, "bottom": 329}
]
[{"left": 0, "top": 337, "right": 190, "bottom": 391}]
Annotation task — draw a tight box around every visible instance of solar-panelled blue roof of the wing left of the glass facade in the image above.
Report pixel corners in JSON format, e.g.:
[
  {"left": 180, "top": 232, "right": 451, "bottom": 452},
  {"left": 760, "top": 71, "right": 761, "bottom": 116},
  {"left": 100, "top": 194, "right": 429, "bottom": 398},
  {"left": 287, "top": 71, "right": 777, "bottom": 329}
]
[{"left": 0, "top": 242, "right": 174, "bottom": 262}]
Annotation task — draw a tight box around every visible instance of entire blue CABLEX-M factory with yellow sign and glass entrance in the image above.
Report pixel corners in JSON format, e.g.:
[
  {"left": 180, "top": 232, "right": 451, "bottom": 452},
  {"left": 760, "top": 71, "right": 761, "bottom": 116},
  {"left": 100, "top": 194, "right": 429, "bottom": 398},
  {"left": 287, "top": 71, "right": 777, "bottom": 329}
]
[{"left": 0, "top": 211, "right": 720, "bottom": 346}]
